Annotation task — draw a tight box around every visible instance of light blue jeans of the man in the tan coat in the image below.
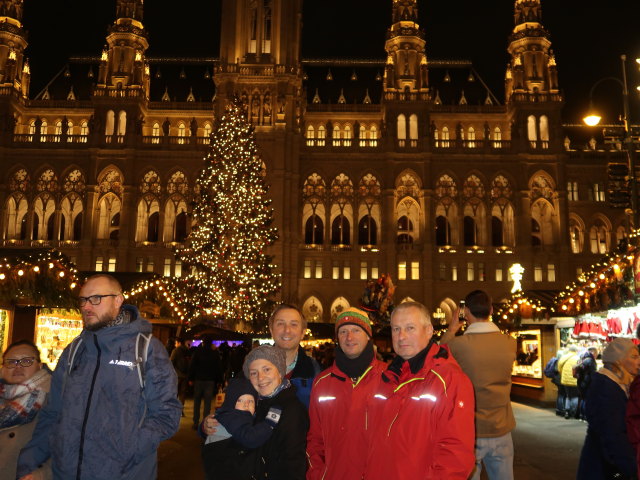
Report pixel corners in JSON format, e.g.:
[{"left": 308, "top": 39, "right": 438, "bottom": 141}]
[{"left": 471, "top": 432, "right": 513, "bottom": 480}]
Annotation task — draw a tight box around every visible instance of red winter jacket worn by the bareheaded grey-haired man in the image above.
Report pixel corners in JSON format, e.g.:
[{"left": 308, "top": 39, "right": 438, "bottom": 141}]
[{"left": 364, "top": 343, "right": 475, "bottom": 480}]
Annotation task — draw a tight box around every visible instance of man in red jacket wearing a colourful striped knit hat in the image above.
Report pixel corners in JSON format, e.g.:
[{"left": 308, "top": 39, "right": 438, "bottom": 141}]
[{"left": 307, "top": 308, "right": 386, "bottom": 480}]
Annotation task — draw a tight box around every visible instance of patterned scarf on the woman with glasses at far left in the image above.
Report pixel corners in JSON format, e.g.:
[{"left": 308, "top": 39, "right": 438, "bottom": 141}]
[{"left": 0, "top": 368, "right": 51, "bottom": 428}]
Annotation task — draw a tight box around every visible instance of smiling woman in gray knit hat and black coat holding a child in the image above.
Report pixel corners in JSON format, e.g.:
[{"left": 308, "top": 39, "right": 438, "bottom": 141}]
[{"left": 242, "top": 345, "right": 309, "bottom": 480}]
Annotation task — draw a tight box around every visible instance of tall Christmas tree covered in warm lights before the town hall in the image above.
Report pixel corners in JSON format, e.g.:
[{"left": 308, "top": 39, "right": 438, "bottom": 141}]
[{"left": 176, "top": 99, "right": 280, "bottom": 329}]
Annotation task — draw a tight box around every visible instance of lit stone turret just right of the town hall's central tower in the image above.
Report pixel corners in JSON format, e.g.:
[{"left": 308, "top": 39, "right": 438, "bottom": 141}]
[{"left": 384, "top": 0, "right": 429, "bottom": 93}]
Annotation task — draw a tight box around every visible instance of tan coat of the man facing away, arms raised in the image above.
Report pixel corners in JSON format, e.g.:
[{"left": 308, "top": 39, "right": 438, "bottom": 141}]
[{"left": 447, "top": 328, "right": 516, "bottom": 438}]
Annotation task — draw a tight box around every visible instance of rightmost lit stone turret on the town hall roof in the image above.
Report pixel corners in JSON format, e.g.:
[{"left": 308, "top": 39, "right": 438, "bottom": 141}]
[{"left": 505, "top": 0, "right": 560, "bottom": 101}]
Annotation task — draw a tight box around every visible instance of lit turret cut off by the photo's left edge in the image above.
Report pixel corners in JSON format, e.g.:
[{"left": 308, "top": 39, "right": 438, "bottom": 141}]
[{"left": 0, "top": 0, "right": 31, "bottom": 98}]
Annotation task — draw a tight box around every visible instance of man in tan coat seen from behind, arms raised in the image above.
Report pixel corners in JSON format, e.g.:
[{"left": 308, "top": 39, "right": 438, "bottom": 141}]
[{"left": 440, "top": 290, "right": 516, "bottom": 480}]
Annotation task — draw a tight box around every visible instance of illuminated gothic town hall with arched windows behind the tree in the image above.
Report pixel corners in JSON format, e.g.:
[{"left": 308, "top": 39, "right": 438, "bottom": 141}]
[{"left": 0, "top": 0, "right": 628, "bottom": 321}]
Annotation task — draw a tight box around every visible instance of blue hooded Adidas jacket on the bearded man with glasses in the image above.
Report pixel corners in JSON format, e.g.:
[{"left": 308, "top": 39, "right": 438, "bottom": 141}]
[{"left": 18, "top": 305, "right": 182, "bottom": 480}]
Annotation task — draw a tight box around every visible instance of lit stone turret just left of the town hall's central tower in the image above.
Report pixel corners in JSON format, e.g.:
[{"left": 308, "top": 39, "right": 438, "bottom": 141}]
[{"left": 96, "top": 0, "right": 149, "bottom": 98}]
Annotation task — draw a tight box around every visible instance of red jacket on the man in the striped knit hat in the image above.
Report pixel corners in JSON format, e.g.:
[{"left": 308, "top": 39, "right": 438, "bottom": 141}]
[{"left": 307, "top": 358, "right": 387, "bottom": 480}]
